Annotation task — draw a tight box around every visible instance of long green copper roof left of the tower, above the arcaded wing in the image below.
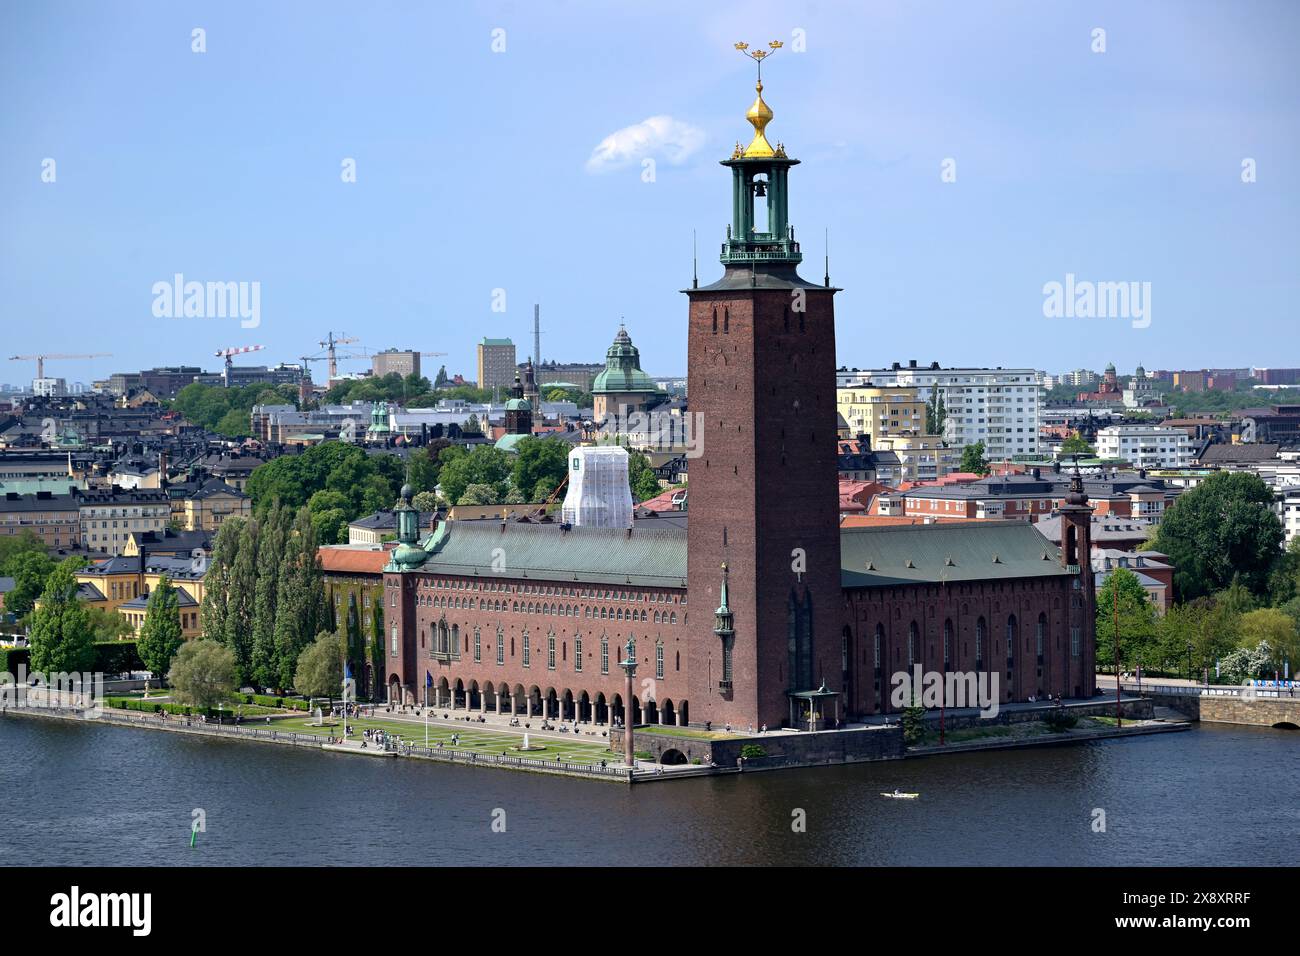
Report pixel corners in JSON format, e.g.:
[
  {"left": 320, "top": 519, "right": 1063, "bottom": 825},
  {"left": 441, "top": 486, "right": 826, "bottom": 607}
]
[{"left": 405, "top": 520, "right": 686, "bottom": 588}]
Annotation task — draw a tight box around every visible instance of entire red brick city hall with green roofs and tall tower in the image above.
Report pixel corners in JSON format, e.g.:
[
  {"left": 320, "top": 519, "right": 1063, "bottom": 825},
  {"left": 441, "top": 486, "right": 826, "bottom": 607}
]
[{"left": 384, "top": 43, "right": 1095, "bottom": 730}]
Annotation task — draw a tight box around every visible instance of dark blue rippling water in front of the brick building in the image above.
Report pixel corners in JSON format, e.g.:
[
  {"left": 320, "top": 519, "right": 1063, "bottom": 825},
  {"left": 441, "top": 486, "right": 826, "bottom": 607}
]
[{"left": 0, "top": 718, "right": 1300, "bottom": 866}]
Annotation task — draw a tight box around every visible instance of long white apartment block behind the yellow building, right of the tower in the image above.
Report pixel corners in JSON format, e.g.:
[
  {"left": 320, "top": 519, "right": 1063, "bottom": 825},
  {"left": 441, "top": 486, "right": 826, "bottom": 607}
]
[{"left": 836, "top": 362, "right": 1044, "bottom": 462}]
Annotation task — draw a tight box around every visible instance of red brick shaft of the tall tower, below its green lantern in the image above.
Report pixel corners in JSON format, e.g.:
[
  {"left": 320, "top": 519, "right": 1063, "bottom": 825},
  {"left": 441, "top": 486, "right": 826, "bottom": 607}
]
[{"left": 688, "top": 289, "right": 842, "bottom": 727}]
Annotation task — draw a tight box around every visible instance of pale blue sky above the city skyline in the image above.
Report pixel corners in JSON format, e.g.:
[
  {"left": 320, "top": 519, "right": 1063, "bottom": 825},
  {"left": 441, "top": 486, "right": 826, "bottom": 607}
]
[{"left": 0, "top": 0, "right": 1300, "bottom": 381}]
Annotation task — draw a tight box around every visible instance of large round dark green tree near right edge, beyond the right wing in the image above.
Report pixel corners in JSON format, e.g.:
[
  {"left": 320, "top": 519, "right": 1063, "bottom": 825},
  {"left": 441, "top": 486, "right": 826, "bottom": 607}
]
[{"left": 1153, "top": 471, "right": 1283, "bottom": 600}]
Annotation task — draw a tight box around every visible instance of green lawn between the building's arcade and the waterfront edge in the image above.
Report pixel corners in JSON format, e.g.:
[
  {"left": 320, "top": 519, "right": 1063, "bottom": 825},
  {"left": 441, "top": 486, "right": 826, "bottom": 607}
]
[{"left": 263, "top": 717, "right": 623, "bottom": 765}]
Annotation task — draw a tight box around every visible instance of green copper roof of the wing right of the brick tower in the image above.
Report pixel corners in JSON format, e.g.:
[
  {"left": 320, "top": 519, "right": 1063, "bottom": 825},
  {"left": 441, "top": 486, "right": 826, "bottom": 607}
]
[{"left": 840, "top": 522, "right": 1070, "bottom": 588}]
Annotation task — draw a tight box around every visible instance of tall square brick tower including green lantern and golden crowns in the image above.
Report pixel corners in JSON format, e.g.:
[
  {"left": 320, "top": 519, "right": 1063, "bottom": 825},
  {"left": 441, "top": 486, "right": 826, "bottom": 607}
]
[{"left": 685, "top": 43, "right": 844, "bottom": 728}]
